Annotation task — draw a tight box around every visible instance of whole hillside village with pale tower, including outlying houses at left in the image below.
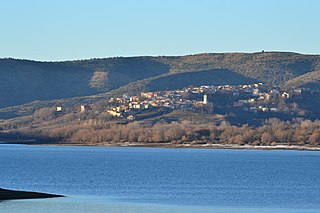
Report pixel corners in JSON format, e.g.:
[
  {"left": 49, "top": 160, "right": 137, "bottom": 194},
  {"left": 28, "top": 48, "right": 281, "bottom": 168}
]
[{"left": 56, "top": 83, "right": 316, "bottom": 121}]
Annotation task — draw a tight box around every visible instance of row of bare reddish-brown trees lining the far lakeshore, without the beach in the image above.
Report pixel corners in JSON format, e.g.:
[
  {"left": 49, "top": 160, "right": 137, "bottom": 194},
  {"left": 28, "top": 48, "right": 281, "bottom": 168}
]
[{"left": 13, "top": 119, "right": 320, "bottom": 146}]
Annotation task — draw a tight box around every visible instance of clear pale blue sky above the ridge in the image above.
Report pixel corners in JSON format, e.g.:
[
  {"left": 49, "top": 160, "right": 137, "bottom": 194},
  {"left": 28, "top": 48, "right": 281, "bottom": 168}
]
[{"left": 0, "top": 0, "right": 320, "bottom": 61}]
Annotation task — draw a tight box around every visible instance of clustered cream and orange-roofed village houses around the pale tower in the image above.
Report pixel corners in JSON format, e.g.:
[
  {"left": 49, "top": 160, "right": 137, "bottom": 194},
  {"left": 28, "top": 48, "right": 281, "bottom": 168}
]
[{"left": 56, "top": 83, "right": 301, "bottom": 120}]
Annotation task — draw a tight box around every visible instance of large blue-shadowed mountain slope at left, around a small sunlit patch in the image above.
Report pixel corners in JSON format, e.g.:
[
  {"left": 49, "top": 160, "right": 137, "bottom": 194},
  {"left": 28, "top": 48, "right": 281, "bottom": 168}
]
[{"left": 0, "top": 58, "right": 167, "bottom": 108}]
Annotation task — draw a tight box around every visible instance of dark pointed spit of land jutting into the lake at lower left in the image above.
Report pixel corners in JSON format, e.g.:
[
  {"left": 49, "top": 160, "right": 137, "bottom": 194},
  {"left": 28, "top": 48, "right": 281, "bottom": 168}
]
[{"left": 0, "top": 188, "right": 64, "bottom": 201}]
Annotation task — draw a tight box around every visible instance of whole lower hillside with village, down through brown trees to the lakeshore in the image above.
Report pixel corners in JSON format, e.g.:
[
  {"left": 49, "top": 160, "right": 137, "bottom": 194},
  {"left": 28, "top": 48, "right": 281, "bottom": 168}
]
[{"left": 0, "top": 83, "right": 320, "bottom": 147}]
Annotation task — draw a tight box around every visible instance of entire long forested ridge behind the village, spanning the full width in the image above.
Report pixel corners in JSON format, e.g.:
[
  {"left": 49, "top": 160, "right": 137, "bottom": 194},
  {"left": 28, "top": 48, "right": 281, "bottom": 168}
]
[{"left": 0, "top": 52, "right": 320, "bottom": 108}]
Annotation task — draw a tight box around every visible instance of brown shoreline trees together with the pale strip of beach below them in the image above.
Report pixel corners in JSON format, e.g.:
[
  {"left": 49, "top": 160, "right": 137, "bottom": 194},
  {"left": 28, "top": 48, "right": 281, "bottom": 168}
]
[{"left": 0, "top": 115, "right": 320, "bottom": 150}]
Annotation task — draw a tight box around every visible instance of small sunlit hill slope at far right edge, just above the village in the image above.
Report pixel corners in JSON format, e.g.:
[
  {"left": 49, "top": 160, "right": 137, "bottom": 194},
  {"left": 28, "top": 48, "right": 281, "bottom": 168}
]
[{"left": 284, "top": 70, "right": 320, "bottom": 89}]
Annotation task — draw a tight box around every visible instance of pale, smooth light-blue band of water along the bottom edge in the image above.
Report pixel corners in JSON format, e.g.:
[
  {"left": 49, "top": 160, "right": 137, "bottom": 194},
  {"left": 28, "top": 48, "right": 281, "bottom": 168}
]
[{"left": 0, "top": 197, "right": 319, "bottom": 213}]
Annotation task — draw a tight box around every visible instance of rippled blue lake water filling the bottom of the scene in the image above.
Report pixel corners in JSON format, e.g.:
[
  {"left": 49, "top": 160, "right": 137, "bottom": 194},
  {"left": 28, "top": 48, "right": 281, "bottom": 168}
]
[{"left": 0, "top": 145, "right": 320, "bottom": 213}]
